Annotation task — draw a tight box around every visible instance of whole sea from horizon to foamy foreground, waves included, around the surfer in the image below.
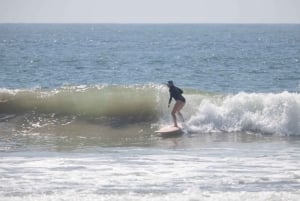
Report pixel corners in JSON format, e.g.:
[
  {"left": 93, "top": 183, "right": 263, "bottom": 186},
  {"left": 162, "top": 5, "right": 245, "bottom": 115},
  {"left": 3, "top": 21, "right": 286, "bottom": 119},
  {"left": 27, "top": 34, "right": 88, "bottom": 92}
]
[{"left": 0, "top": 24, "right": 300, "bottom": 201}]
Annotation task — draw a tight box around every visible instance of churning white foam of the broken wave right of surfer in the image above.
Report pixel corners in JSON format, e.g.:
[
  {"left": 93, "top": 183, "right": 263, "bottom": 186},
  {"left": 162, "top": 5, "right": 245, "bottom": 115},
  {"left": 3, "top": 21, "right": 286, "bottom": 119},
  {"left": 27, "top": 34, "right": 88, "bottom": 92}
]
[{"left": 188, "top": 92, "right": 300, "bottom": 135}]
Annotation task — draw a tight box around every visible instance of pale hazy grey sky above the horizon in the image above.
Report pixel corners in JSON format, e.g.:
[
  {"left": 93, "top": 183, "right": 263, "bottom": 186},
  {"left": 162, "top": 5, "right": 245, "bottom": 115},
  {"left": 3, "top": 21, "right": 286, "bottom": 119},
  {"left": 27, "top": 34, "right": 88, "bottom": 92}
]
[{"left": 0, "top": 0, "right": 300, "bottom": 23}]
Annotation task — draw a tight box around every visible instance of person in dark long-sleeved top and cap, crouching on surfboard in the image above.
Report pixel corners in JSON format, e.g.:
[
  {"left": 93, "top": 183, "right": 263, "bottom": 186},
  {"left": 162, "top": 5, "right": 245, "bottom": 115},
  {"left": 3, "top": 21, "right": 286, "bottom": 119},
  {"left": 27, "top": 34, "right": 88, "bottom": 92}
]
[{"left": 167, "top": 80, "right": 185, "bottom": 127}]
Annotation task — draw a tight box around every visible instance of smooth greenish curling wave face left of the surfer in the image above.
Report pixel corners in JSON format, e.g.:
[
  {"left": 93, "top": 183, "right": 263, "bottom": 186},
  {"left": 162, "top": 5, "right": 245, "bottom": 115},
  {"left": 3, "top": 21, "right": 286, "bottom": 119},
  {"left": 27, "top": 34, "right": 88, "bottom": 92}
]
[{"left": 0, "top": 85, "right": 164, "bottom": 120}]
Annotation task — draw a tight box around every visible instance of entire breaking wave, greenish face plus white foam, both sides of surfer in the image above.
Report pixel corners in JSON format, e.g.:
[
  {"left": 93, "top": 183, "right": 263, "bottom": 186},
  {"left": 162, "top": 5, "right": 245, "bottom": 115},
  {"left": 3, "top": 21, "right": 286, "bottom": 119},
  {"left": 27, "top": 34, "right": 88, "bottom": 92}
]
[{"left": 0, "top": 84, "right": 300, "bottom": 135}]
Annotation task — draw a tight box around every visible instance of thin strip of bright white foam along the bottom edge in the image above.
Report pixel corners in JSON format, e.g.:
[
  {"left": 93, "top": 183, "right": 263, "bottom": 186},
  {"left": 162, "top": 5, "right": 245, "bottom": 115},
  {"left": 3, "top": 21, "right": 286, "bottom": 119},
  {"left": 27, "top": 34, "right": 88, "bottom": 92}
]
[{"left": 2, "top": 190, "right": 299, "bottom": 201}]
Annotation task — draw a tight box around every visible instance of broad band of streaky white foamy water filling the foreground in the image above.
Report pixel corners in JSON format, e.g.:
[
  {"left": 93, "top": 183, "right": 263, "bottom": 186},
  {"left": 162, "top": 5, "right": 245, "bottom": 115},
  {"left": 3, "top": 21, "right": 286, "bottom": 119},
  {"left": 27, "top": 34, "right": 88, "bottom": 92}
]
[{"left": 0, "top": 144, "right": 300, "bottom": 201}]
